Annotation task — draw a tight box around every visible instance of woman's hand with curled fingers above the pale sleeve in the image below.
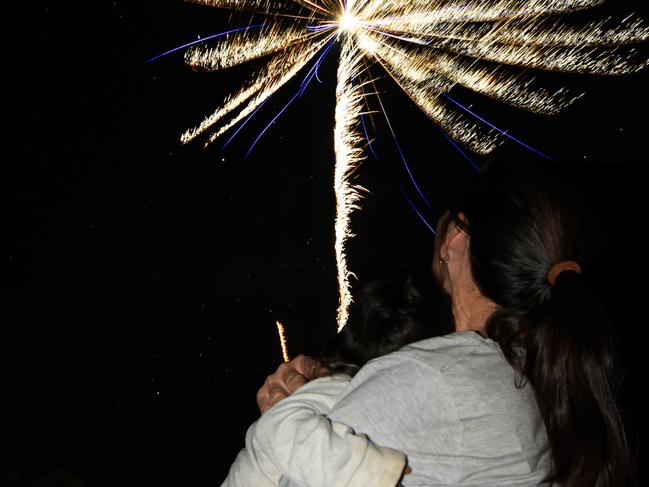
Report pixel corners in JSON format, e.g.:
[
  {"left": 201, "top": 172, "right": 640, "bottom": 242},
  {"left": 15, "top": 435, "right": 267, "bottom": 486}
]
[{"left": 257, "top": 355, "right": 330, "bottom": 414}]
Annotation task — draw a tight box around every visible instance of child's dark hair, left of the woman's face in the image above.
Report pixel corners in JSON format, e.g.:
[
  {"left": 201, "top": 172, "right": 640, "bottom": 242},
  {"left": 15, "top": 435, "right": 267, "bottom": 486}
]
[{"left": 322, "top": 270, "right": 455, "bottom": 367}]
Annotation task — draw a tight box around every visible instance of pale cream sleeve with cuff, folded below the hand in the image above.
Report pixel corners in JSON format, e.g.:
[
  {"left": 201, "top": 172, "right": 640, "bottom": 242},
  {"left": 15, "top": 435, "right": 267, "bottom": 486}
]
[{"left": 240, "top": 376, "right": 406, "bottom": 487}]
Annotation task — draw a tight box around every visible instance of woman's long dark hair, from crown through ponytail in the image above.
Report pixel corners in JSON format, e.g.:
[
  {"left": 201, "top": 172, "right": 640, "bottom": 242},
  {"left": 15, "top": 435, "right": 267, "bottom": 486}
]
[{"left": 450, "top": 163, "right": 633, "bottom": 487}]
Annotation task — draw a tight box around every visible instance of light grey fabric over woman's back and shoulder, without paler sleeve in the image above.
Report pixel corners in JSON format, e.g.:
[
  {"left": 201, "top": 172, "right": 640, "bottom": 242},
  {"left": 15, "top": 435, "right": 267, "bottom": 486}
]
[{"left": 329, "top": 332, "right": 551, "bottom": 486}]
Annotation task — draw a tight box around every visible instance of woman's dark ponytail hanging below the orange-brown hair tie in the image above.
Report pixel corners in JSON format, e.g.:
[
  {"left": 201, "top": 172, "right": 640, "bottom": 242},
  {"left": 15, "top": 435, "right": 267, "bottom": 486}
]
[{"left": 487, "top": 272, "right": 634, "bottom": 487}]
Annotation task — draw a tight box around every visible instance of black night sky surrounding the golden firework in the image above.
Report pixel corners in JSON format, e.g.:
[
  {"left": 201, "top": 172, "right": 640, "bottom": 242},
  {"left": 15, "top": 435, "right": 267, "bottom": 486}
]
[{"left": 5, "top": 0, "right": 649, "bottom": 486}]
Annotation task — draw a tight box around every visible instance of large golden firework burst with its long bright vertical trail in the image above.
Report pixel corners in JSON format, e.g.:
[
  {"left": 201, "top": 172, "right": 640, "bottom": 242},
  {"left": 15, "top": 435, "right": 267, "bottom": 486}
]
[{"left": 175, "top": 0, "right": 649, "bottom": 330}]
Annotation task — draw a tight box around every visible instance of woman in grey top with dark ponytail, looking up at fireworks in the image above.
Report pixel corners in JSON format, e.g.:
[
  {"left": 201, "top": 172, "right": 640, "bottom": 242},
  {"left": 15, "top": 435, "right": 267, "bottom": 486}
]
[{"left": 253, "top": 163, "right": 632, "bottom": 486}]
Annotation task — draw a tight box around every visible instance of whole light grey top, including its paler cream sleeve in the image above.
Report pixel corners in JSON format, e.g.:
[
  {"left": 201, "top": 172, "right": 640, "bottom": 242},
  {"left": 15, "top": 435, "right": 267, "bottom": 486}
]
[{"left": 224, "top": 332, "right": 551, "bottom": 487}]
